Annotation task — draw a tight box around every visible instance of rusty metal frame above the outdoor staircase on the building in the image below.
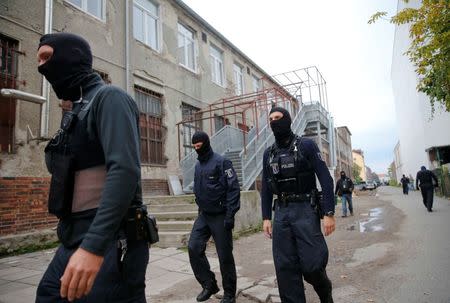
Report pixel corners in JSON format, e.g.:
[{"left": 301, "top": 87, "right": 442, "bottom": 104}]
[{"left": 176, "top": 66, "right": 328, "bottom": 161}]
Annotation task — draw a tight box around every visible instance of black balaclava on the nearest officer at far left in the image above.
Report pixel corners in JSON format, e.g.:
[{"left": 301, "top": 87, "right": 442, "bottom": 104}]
[{"left": 38, "top": 33, "right": 92, "bottom": 101}]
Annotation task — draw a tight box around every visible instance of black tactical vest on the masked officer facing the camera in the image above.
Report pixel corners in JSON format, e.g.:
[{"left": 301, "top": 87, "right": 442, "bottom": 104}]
[{"left": 267, "top": 136, "right": 315, "bottom": 194}]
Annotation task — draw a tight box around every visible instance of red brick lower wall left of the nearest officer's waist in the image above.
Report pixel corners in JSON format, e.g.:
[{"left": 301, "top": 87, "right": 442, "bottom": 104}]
[{"left": 0, "top": 177, "right": 58, "bottom": 236}]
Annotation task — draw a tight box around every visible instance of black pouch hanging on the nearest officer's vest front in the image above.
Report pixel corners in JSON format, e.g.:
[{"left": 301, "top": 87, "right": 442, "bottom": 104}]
[{"left": 48, "top": 151, "right": 75, "bottom": 218}]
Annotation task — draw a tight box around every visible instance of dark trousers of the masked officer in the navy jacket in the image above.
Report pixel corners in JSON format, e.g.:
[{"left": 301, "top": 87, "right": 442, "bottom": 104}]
[{"left": 188, "top": 212, "right": 236, "bottom": 297}]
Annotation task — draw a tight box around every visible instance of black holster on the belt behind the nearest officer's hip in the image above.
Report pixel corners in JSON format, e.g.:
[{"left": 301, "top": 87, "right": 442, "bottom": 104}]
[{"left": 125, "top": 205, "right": 159, "bottom": 244}]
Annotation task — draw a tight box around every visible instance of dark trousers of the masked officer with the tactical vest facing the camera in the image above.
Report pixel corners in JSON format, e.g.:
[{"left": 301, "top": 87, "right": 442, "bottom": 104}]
[{"left": 272, "top": 202, "right": 333, "bottom": 303}]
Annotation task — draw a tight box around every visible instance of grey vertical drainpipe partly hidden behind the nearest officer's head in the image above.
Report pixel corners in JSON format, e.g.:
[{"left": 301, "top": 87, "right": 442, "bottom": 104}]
[{"left": 41, "top": 0, "right": 53, "bottom": 137}]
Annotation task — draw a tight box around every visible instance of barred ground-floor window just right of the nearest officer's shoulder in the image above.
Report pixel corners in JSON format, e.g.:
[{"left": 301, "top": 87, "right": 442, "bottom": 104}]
[{"left": 134, "top": 85, "right": 165, "bottom": 164}]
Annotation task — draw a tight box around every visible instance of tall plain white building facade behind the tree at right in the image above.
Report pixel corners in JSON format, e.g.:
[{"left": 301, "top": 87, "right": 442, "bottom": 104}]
[{"left": 391, "top": 0, "right": 450, "bottom": 178}]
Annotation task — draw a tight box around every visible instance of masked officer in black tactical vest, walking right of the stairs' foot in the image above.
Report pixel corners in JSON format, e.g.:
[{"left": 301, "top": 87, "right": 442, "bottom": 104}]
[{"left": 261, "top": 107, "right": 335, "bottom": 303}]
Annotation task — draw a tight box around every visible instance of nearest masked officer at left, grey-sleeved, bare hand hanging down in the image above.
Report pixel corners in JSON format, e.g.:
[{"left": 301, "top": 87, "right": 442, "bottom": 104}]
[{"left": 36, "top": 33, "right": 149, "bottom": 303}]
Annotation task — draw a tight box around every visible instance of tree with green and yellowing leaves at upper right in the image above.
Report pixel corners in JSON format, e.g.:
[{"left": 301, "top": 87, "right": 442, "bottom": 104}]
[{"left": 368, "top": 0, "right": 450, "bottom": 112}]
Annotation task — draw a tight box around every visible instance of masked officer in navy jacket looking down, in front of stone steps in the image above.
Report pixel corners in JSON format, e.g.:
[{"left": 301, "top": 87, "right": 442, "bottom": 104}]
[{"left": 188, "top": 131, "right": 240, "bottom": 303}]
